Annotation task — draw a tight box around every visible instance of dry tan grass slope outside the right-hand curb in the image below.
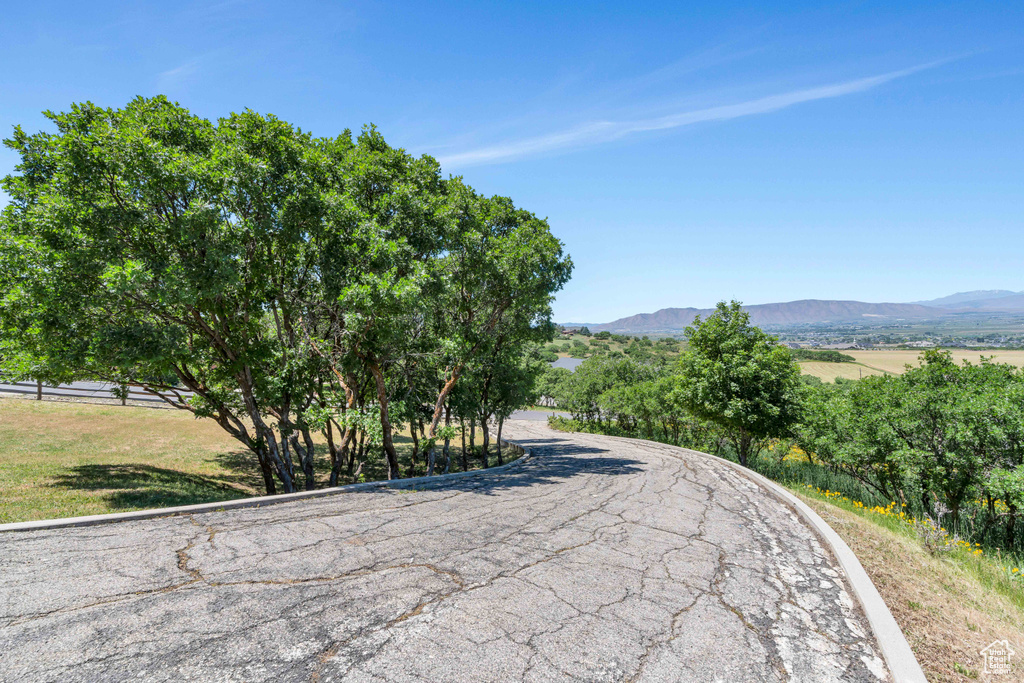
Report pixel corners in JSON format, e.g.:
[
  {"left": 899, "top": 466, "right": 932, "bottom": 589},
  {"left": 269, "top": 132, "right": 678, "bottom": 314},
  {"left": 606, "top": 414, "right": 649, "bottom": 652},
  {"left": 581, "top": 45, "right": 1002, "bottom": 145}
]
[{"left": 794, "top": 488, "right": 1024, "bottom": 682}]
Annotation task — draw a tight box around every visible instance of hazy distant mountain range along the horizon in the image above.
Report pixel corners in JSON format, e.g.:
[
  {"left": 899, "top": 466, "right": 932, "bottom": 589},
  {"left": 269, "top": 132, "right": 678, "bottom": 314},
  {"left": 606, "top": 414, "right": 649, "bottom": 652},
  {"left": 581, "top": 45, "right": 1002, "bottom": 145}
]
[{"left": 564, "top": 290, "right": 1024, "bottom": 334}]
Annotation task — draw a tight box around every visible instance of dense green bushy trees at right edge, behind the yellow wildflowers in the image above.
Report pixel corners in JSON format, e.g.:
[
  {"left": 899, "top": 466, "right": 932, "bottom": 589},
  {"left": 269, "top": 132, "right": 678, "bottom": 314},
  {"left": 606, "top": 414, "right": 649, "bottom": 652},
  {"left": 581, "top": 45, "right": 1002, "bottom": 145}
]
[{"left": 795, "top": 350, "right": 1024, "bottom": 538}]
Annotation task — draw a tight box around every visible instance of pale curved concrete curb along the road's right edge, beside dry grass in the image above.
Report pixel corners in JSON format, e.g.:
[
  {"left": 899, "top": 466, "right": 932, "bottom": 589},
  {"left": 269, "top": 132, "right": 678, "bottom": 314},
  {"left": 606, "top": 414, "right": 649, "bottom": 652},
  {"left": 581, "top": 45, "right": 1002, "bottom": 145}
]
[{"left": 694, "top": 451, "right": 928, "bottom": 683}]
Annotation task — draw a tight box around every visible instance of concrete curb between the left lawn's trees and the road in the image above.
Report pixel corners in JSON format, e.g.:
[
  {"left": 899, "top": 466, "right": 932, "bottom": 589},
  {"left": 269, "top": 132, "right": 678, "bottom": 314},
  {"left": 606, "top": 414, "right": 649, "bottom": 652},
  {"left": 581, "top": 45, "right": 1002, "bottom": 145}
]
[{"left": 0, "top": 439, "right": 534, "bottom": 532}]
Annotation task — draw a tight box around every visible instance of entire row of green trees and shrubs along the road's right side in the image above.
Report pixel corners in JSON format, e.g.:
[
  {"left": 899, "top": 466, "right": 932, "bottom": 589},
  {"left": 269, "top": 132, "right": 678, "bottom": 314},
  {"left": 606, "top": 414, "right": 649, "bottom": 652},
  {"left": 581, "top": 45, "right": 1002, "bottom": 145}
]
[{"left": 540, "top": 302, "right": 1024, "bottom": 547}]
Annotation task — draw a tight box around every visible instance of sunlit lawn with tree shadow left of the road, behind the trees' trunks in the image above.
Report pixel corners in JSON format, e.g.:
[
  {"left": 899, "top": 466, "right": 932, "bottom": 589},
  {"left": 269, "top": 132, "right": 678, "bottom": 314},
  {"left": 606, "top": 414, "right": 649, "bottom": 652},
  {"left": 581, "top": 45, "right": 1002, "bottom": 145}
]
[{"left": 0, "top": 397, "right": 509, "bottom": 523}]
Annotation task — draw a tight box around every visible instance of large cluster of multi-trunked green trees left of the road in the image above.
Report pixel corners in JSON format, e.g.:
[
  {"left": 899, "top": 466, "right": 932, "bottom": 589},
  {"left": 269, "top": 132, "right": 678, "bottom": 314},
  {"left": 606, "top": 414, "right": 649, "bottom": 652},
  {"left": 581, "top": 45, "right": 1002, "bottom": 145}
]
[{"left": 0, "top": 97, "right": 571, "bottom": 494}]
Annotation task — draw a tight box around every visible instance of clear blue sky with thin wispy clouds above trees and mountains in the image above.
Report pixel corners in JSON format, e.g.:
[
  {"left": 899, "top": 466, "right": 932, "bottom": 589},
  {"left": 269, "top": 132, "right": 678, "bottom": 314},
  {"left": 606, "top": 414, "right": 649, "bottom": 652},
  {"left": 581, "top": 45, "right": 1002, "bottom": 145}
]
[{"left": 0, "top": 0, "right": 1024, "bottom": 322}]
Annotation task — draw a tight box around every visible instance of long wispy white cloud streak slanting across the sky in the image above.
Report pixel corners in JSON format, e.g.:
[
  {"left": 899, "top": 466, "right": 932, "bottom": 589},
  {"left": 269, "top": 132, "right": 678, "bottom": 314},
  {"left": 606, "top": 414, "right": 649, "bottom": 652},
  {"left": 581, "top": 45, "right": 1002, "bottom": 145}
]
[{"left": 437, "top": 60, "right": 946, "bottom": 168}]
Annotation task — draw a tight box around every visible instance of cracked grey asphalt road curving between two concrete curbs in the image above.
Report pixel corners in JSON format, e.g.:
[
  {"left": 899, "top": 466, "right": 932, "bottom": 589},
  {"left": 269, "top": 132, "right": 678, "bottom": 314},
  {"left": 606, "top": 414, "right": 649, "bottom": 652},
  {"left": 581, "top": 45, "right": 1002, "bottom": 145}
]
[{"left": 0, "top": 421, "right": 888, "bottom": 683}]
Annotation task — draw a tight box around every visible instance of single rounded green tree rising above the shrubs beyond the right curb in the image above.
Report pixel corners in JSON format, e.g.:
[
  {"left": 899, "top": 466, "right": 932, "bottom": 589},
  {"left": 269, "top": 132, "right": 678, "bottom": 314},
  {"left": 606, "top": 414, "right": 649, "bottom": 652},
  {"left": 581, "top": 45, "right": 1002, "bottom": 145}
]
[{"left": 678, "top": 301, "right": 801, "bottom": 466}]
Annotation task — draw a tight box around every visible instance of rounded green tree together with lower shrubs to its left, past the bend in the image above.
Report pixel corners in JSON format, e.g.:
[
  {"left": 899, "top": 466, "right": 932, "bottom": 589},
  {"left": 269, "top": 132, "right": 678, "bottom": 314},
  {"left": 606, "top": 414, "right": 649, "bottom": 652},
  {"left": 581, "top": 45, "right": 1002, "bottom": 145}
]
[{"left": 540, "top": 301, "right": 801, "bottom": 465}]
